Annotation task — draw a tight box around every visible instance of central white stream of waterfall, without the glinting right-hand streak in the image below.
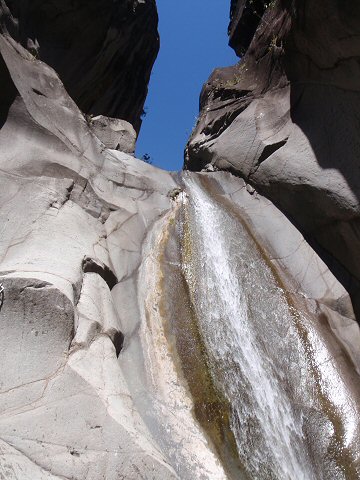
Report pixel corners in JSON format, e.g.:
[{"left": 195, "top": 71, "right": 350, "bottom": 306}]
[{"left": 180, "top": 177, "right": 322, "bottom": 480}]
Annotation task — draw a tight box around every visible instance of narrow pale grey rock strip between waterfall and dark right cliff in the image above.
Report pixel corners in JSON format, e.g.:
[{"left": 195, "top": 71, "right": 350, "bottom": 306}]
[{"left": 202, "top": 172, "right": 360, "bottom": 356}]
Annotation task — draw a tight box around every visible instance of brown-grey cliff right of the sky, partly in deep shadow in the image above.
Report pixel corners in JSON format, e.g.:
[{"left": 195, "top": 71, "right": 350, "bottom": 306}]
[{"left": 185, "top": 0, "right": 360, "bottom": 318}]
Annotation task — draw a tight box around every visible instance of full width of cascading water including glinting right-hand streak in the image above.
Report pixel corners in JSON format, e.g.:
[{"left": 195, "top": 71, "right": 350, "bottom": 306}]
[{"left": 174, "top": 175, "right": 358, "bottom": 480}]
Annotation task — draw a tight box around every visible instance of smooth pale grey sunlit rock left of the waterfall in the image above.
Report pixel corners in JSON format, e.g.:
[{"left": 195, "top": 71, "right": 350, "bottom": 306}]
[{"left": 0, "top": 16, "right": 228, "bottom": 480}]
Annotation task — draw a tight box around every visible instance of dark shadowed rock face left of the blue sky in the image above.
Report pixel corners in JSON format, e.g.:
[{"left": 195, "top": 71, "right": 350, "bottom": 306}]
[{"left": 1, "top": 0, "right": 159, "bottom": 131}]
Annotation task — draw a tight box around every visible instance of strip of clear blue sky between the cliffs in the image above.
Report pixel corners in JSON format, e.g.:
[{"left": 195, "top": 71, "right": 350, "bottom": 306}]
[{"left": 136, "top": 0, "right": 238, "bottom": 170}]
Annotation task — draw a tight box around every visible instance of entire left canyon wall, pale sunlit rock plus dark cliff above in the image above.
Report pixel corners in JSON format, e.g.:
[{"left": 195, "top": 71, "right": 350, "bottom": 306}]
[{"left": 0, "top": 1, "right": 176, "bottom": 480}]
